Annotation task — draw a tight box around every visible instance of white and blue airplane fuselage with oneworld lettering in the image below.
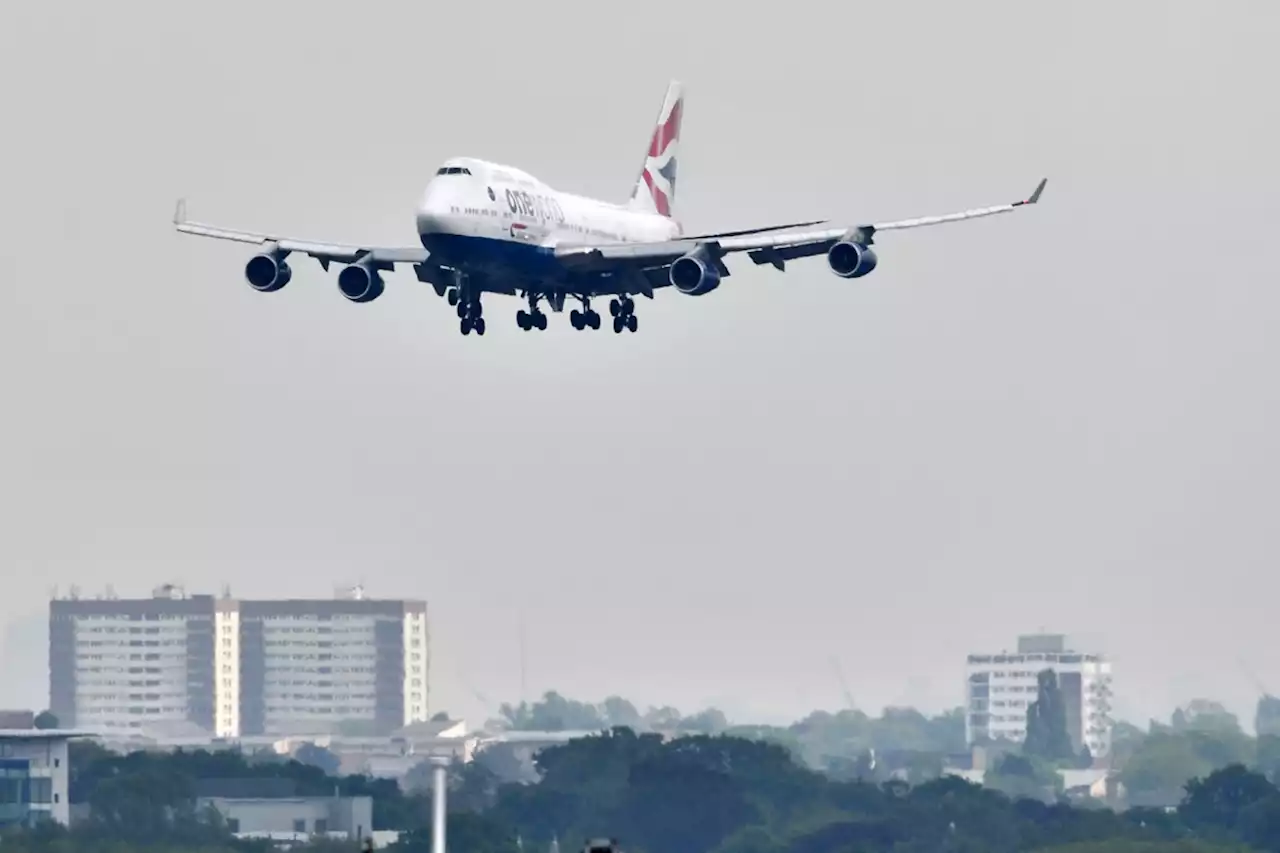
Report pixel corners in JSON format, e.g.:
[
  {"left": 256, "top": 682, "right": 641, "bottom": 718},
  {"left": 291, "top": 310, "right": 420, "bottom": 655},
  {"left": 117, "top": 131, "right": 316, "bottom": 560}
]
[{"left": 417, "top": 158, "right": 681, "bottom": 265}]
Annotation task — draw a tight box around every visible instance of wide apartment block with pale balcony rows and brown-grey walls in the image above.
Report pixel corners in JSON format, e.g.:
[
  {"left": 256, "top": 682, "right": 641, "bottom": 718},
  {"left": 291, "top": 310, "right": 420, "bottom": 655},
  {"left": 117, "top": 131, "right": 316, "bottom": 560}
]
[{"left": 49, "top": 587, "right": 430, "bottom": 738}]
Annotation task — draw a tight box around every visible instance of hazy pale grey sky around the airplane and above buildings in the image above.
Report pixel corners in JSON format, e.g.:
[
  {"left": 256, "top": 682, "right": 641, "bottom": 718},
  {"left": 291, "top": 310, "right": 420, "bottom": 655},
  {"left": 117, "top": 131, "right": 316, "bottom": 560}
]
[{"left": 0, "top": 0, "right": 1280, "bottom": 717}]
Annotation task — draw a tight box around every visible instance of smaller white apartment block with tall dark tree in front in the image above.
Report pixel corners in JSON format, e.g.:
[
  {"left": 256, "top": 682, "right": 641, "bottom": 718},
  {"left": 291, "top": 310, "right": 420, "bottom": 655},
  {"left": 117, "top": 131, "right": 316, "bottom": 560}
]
[{"left": 965, "top": 634, "right": 1114, "bottom": 757}]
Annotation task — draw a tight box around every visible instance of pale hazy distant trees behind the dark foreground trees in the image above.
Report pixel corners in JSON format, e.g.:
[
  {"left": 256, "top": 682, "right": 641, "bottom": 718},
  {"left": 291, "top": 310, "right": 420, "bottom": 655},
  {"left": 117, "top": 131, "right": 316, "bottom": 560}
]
[{"left": 489, "top": 678, "right": 1280, "bottom": 806}]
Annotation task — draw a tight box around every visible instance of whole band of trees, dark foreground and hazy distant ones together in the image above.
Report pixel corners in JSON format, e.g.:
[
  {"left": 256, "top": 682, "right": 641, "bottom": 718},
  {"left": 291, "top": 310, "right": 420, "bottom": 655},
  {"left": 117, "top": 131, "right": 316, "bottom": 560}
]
[{"left": 24, "top": 679, "right": 1280, "bottom": 853}]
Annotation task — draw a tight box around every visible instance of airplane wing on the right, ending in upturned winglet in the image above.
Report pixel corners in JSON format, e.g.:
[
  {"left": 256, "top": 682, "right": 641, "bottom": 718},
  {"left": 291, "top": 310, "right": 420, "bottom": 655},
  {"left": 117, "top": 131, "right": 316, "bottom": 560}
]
[{"left": 556, "top": 178, "right": 1048, "bottom": 269}]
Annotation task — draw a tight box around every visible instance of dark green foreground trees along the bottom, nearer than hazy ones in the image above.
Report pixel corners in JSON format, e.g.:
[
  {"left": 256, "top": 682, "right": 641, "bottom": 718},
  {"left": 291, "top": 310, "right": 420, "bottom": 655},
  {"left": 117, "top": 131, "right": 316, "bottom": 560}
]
[{"left": 0, "top": 729, "right": 1280, "bottom": 853}]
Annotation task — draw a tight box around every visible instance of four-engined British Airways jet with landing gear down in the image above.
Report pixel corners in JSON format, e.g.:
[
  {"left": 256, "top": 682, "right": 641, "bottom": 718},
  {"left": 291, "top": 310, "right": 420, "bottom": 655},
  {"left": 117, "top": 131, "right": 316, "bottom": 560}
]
[{"left": 174, "top": 82, "right": 1046, "bottom": 334}]
